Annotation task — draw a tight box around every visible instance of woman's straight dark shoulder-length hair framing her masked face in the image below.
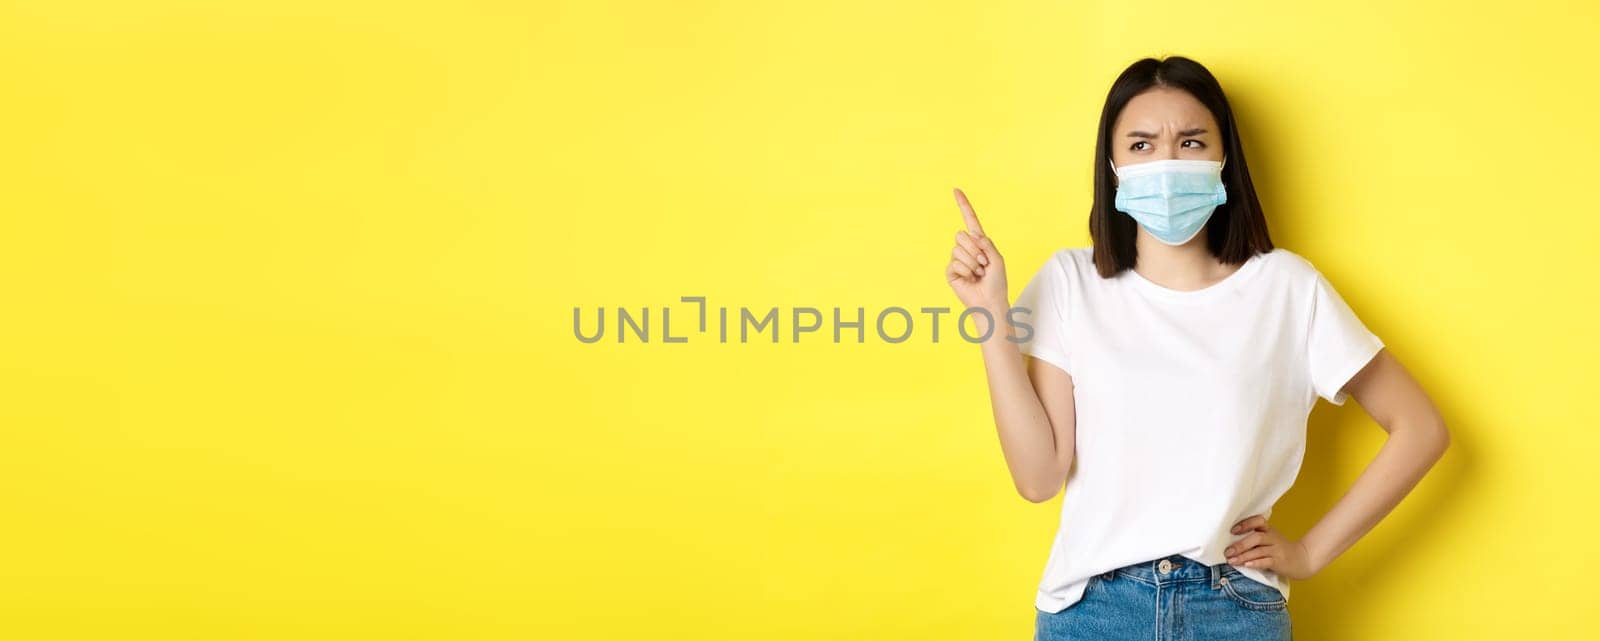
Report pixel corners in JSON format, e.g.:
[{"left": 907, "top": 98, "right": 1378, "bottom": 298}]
[{"left": 1090, "top": 56, "right": 1272, "bottom": 278}]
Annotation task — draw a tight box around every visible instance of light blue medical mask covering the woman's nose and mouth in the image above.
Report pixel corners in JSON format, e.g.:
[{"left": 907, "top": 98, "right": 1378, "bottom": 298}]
[{"left": 1110, "top": 158, "right": 1227, "bottom": 245}]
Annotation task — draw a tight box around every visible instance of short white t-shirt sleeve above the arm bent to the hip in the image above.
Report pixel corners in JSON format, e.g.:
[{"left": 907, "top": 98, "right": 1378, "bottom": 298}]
[{"left": 1307, "top": 273, "right": 1384, "bottom": 404}]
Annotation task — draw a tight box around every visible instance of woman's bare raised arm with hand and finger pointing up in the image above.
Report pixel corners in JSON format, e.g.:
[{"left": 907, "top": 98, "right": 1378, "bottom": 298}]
[{"left": 944, "top": 190, "right": 1077, "bottom": 504}]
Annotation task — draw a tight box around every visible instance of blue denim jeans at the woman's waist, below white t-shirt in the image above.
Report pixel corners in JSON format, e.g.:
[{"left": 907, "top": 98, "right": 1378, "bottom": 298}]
[{"left": 1034, "top": 555, "right": 1293, "bottom": 641}]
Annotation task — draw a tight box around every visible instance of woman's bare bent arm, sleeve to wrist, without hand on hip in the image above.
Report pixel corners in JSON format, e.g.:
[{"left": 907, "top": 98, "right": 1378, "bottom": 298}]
[{"left": 1301, "top": 348, "right": 1450, "bottom": 574}]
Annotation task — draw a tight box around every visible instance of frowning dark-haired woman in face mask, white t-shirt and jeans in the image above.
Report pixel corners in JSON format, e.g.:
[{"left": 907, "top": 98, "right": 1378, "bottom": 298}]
[{"left": 946, "top": 56, "right": 1450, "bottom": 641}]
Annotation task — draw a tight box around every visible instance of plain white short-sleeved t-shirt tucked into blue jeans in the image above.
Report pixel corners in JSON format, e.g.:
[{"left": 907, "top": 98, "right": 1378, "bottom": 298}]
[{"left": 1016, "top": 242, "right": 1384, "bottom": 612}]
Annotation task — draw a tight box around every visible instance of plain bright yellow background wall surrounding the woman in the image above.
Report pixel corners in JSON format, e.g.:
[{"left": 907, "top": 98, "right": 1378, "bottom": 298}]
[{"left": 0, "top": 0, "right": 1600, "bottom": 639}]
